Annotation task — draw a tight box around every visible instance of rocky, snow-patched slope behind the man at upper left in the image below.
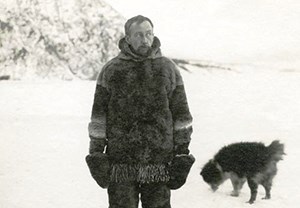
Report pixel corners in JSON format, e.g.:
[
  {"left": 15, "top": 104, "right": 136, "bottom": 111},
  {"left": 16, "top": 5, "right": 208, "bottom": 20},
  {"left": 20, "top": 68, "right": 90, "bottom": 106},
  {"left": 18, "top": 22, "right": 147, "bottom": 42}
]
[{"left": 0, "top": 0, "right": 125, "bottom": 80}]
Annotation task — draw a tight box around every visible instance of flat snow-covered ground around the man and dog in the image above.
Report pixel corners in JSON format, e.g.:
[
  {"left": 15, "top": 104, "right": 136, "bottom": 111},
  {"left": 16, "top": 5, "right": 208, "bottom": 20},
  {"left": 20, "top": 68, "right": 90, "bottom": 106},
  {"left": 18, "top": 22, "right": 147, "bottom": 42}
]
[{"left": 0, "top": 66, "right": 300, "bottom": 208}]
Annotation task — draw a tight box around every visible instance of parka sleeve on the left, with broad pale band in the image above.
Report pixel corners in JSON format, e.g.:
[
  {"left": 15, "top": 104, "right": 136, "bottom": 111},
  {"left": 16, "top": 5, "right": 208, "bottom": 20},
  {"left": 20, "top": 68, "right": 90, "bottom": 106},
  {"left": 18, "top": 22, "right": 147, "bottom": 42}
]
[{"left": 88, "top": 66, "right": 109, "bottom": 154}]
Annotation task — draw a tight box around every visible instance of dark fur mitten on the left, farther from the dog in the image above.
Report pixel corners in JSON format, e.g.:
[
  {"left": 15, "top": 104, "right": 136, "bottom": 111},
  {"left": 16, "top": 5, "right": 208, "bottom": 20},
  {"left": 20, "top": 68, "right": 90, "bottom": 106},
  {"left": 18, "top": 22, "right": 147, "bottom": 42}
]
[{"left": 85, "top": 152, "right": 110, "bottom": 188}]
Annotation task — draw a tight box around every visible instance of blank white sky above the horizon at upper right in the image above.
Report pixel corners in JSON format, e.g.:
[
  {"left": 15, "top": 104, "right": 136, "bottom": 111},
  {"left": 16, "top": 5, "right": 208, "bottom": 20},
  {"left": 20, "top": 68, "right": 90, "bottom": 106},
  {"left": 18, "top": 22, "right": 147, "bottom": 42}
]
[{"left": 106, "top": 0, "right": 300, "bottom": 65}]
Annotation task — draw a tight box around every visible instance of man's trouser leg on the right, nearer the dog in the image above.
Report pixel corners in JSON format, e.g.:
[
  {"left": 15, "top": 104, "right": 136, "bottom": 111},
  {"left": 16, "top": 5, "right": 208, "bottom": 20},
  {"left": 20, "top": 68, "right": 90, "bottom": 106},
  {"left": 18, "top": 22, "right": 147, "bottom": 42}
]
[{"left": 141, "top": 183, "right": 171, "bottom": 208}]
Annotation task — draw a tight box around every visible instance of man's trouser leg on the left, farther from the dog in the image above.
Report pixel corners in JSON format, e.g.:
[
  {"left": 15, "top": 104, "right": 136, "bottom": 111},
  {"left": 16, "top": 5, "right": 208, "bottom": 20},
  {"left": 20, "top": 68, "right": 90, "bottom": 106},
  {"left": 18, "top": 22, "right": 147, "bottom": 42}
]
[{"left": 107, "top": 182, "right": 139, "bottom": 208}]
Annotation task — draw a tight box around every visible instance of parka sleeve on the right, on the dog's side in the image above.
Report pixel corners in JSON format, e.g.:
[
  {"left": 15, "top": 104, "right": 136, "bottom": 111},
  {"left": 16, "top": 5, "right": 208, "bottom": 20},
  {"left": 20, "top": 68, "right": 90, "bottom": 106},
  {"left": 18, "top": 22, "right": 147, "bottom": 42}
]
[{"left": 170, "top": 68, "right": 193, "bottom": 154}]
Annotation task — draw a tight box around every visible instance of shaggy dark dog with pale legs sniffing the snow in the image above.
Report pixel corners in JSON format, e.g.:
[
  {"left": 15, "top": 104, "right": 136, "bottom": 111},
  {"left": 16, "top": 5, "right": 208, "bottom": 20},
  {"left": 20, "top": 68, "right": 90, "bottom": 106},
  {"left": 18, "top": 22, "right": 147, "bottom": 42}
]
[{"left": 200, "top": 140, "right": 285, "bottom": 204}]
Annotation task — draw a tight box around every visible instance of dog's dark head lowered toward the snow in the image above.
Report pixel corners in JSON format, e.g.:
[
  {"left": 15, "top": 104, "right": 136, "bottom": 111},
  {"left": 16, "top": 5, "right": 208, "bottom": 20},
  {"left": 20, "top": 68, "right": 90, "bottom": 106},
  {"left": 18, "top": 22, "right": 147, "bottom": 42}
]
[{"left": 200, "top": 160, "right": 224, "bottom": 191}]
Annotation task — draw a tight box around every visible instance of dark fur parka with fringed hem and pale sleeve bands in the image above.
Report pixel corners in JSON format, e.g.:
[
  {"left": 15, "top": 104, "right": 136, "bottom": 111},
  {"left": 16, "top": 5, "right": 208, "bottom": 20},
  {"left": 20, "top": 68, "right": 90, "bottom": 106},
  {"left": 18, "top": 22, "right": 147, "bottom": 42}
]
[{"left": 89, "top": 37, "right": 192, "bottom": 183}]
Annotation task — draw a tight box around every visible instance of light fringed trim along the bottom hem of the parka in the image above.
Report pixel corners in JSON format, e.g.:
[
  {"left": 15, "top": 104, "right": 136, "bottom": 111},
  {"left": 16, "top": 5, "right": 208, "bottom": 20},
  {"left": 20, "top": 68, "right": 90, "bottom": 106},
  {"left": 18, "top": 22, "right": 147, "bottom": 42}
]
[{"left": 110, "top": 164, "right": 170, "bottom": 183}]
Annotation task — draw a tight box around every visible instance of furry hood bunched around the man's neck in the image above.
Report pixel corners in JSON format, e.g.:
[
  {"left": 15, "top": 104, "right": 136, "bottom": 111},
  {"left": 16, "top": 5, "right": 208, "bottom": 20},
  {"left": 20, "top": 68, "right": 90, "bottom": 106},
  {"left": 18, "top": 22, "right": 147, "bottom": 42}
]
[{"left": 118, "top": 37, "right": 162, "bottom": 62}]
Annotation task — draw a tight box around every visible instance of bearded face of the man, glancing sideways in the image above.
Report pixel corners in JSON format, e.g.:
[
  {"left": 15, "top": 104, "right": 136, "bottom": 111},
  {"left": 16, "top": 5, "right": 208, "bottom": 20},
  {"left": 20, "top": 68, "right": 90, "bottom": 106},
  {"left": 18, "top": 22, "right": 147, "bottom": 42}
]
[{"left": 126, "top": 21, "right": 154, "bottom": 56}]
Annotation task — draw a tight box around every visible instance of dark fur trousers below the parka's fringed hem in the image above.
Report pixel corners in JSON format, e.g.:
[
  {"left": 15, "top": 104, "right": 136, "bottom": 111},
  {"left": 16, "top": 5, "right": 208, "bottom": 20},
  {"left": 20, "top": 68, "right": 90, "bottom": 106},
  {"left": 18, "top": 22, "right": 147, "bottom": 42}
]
[{"left": 107, "top": 182, "right": 171, "bottom": 208}]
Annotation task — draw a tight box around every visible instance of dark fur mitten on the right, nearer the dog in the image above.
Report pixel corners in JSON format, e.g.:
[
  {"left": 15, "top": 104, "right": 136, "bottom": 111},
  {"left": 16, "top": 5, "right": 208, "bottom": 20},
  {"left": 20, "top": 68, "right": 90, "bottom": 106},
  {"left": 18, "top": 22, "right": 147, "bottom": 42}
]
[{"left": 167, "top": 154, "right": 195, "bottom": 189}]
